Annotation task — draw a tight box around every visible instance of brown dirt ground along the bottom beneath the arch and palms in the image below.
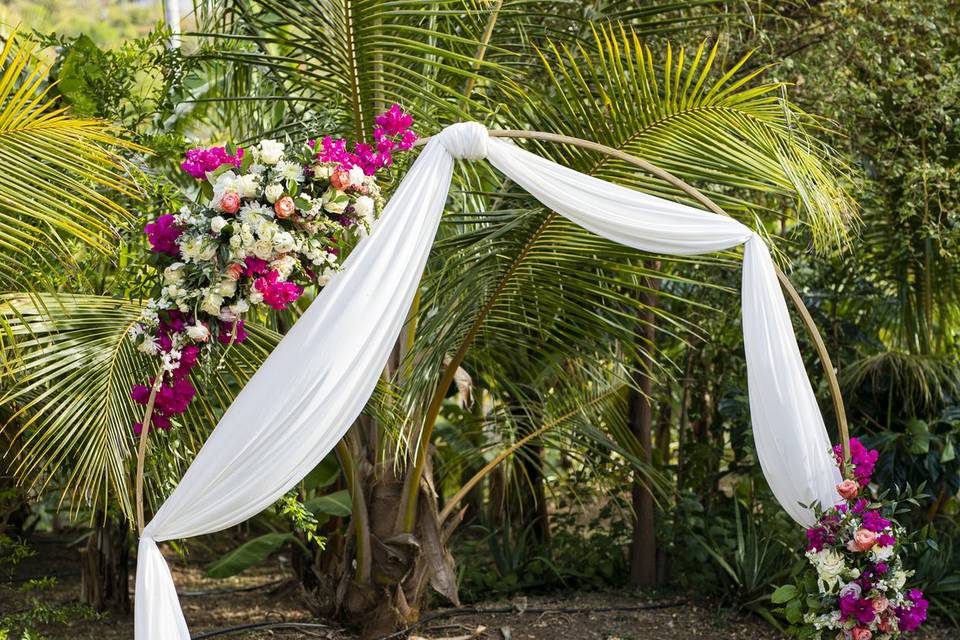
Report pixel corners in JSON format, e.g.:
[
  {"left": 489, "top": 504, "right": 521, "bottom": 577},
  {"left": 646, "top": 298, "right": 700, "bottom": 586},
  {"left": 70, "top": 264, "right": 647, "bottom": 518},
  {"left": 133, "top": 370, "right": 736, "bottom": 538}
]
[{"left": 0, "top": 541, "right": 960, "bottom": 640}]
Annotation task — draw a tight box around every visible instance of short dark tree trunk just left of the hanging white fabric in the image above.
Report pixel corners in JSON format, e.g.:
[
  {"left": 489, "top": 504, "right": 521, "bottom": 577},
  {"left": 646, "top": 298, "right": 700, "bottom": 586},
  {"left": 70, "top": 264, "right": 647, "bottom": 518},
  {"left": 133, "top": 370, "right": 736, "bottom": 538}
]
[{"left": 80, "top": 517, "right": 130, "bottom": 613}]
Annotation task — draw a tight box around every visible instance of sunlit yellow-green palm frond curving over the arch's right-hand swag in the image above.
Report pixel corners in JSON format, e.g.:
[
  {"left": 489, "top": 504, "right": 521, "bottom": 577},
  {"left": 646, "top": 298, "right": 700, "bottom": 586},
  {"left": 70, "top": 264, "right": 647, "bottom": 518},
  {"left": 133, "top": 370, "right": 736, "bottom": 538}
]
[{"left": 502, "top": 26, "right": 855, "bottom": 247}]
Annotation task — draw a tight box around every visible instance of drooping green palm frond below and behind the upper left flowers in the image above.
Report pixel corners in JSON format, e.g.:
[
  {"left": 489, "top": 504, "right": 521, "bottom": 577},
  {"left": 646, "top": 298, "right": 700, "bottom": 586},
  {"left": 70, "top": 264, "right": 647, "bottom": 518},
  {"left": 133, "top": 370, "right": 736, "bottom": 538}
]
[{"left": 0, "top": 294, "right": 280, "bottom": 515}]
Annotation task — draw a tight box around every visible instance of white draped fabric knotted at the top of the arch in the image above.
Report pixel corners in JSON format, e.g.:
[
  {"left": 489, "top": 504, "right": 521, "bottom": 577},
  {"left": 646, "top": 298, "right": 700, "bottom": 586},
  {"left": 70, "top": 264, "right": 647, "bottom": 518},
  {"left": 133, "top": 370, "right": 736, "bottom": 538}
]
[{"left": 136, "top": 123, "right": 840, "bottom": 640}]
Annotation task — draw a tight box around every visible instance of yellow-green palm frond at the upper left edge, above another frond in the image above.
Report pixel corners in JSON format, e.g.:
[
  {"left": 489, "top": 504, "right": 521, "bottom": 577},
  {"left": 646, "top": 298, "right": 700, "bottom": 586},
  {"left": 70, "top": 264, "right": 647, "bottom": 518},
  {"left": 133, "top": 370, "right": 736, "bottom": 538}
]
[{"left": 0, "top": 35, "right": 139, "bottom": 290}]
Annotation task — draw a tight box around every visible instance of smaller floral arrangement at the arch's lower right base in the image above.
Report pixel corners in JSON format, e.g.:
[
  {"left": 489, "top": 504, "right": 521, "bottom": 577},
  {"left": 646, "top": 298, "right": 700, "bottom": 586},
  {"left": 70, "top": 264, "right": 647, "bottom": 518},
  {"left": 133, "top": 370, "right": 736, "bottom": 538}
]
[{"left": 772, "top": 438, "right": 928, "bottom": 640}]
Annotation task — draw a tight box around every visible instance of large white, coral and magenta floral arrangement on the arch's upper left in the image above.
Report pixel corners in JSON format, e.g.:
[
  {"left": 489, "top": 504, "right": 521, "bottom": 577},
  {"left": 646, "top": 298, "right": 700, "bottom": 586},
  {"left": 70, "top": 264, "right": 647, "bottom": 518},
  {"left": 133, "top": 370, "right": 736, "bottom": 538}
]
[{"left": 129, "top": 105, "right": 417, "bottom": 433}]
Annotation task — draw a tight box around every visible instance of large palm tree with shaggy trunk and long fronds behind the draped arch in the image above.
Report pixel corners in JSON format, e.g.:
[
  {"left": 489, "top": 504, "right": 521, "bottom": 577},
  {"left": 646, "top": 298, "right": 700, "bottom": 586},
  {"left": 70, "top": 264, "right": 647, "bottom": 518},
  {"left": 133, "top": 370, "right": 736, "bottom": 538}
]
[{"left": 0, "top": 0, "right": 851, "bottom": 634}]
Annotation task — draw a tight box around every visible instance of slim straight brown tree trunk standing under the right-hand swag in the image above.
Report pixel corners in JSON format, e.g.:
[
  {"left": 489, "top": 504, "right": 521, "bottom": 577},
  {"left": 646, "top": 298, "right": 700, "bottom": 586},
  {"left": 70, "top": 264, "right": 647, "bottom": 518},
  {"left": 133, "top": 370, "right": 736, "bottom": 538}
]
[{"left": 630, "top": 262, "right": 659, "bottom": 588}]
